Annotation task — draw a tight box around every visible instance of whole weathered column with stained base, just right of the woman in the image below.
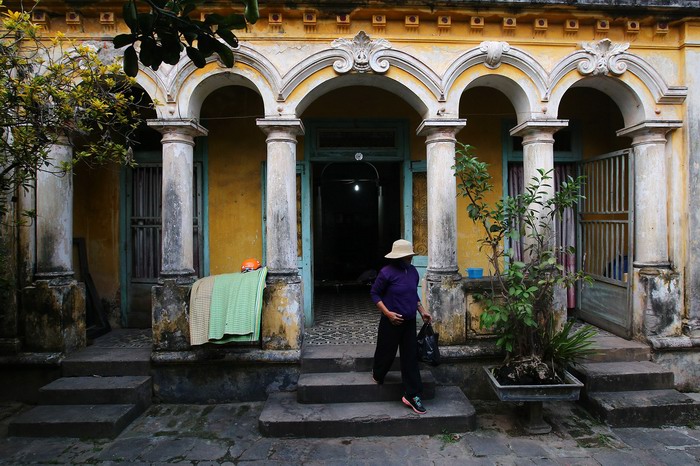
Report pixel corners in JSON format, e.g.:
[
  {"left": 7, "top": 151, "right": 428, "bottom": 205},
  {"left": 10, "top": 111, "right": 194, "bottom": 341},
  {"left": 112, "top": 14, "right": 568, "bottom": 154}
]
[{"left": 417, "top": 119, "right": 467, "bottom": 345}]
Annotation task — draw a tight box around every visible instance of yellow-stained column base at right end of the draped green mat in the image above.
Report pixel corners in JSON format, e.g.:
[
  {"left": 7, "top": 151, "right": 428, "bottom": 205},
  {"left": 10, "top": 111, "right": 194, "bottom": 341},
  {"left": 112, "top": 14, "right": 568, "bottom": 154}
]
[{"left": 260, "top": 271, "right": 304, "bottom": 350}]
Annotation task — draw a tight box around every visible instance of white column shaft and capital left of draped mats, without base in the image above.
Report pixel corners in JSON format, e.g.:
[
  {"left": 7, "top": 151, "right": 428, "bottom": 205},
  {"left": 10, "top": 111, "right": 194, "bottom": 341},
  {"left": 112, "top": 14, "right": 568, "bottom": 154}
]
[{"left": 148, "top": 120, "right": 207, "bottom": 279}]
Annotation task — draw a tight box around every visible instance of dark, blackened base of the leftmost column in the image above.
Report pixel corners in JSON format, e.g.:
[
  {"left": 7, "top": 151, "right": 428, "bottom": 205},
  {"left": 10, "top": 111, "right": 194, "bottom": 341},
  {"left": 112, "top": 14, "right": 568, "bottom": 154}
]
[{"left": 22, "top": 280, "right": 86, "bottom": 353}]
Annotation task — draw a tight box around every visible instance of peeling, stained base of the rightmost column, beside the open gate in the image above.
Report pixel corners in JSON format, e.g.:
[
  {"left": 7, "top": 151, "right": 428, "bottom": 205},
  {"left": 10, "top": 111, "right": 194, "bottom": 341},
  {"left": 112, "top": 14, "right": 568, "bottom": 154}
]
[{"left": 633, "top": 267, "right": 683, "bottom": 338}]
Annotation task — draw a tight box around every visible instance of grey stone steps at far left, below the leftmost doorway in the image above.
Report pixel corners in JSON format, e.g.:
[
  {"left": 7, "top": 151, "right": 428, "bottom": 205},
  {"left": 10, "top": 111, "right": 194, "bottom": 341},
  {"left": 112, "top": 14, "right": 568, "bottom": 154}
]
[{"left": 8, "top": 336, "right": 152, "bottom": 438}]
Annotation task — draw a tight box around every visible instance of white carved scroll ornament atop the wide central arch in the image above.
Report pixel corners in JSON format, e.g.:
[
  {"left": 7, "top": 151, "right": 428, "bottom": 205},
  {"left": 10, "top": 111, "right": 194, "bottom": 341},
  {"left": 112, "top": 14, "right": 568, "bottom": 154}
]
[{"left": 331, "top": 31, "right": 391, "bottom": 74}]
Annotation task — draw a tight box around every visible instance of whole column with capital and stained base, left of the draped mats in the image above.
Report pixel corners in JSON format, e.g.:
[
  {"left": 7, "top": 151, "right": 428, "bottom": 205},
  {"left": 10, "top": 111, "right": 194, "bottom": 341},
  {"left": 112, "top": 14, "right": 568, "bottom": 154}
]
[{"left": 148, "top": 120, "right": 207, "bottom": 351}]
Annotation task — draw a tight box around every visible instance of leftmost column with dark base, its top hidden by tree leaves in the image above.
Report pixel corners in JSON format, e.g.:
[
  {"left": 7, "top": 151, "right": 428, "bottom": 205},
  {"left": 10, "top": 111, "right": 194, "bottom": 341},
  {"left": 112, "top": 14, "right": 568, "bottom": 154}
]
[{"left": 22, "top": 139, "right": 85, "bottom": 353}]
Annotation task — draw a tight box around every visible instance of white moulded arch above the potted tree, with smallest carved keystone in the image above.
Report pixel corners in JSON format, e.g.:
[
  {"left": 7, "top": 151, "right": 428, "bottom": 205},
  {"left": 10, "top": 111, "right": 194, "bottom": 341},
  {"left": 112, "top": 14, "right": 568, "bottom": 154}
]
[{"left": 442, "top": 41, "right": 548, "bottom": 122}]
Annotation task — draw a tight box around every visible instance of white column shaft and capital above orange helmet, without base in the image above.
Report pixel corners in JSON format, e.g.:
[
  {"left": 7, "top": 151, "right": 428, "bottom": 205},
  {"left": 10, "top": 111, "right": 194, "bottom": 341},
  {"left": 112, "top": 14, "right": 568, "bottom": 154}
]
[{"left": 258, "top": 118, "right": 304, "bottom": 275}]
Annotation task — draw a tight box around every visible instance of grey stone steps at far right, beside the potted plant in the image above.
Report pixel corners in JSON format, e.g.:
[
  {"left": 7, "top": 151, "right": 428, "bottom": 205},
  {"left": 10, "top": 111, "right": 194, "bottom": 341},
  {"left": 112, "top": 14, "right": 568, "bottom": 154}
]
[{"left": 570, "top": 336, "right": 700, "bottom": 427}]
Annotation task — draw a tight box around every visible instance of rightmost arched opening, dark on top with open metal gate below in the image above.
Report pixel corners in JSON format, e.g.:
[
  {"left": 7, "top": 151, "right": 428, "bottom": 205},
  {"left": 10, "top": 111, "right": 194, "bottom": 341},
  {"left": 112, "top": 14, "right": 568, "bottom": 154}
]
[{"left": 559, "top": 85, "right": 634, "bottom": 337}]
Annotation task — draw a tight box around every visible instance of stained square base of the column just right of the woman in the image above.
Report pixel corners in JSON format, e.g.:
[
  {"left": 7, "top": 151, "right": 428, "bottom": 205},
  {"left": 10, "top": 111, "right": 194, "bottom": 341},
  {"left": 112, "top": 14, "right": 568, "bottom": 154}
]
[{"left": 425, "top": 271, "right": 467, "bottom": 345}]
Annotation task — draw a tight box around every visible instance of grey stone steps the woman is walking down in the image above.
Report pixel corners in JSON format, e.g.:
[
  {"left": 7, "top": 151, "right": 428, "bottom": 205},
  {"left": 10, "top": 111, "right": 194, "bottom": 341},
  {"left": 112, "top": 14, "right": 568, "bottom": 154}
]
[{"left": 258, "top": 345, "right": 476, "bottom": 437}]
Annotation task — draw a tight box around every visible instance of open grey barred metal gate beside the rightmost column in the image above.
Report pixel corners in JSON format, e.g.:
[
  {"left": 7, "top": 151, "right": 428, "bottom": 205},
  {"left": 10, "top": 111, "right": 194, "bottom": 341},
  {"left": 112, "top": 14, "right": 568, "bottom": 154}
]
[{"left": 577, "top": 149, "right": 634, "bottom": 338}]
